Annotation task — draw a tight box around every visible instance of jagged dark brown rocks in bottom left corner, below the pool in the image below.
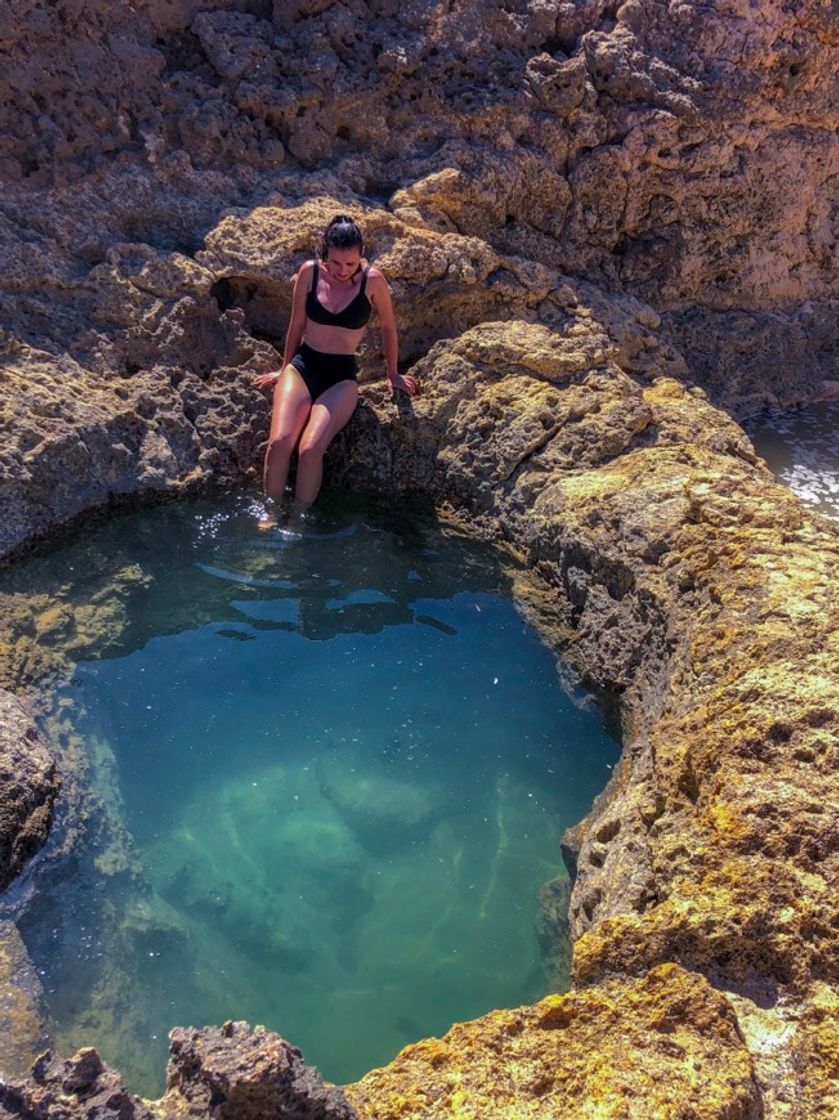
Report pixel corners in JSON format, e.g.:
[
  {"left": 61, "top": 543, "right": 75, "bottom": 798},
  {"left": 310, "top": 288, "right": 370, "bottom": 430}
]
[{"left": 0, "top": 1023, "right": 355, "bottom": 1120}]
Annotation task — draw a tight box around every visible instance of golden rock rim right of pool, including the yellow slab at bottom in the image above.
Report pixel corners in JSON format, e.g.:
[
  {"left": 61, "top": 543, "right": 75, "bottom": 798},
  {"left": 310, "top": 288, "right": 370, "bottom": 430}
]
[{"left": 1, "top": 309, "right": 839, "bottom": 1120}]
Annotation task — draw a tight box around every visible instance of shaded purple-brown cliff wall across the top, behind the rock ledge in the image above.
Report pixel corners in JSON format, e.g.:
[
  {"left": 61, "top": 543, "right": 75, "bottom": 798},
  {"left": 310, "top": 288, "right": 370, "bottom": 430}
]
[{"left": 0, "top": 0, "right": 839, "bottom": 421}]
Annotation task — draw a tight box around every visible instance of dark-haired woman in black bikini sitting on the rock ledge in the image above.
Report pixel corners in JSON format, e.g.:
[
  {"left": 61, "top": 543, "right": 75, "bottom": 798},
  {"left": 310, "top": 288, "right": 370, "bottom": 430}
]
[{"left": 257, "top": 214, "right": 417, "bottom": 519}]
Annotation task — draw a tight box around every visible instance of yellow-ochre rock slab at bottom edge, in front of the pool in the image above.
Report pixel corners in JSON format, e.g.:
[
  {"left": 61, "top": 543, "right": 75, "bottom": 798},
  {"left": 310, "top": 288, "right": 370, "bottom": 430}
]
[{"left": 347, "top": 965, "right": 761, "bottom": 1120}]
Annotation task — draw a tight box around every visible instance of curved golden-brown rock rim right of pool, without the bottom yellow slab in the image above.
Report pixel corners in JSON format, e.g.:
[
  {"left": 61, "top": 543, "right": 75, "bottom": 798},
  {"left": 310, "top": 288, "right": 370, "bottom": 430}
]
[{"left": 329, "top": 323, "right": 839, "bottom": 1117}]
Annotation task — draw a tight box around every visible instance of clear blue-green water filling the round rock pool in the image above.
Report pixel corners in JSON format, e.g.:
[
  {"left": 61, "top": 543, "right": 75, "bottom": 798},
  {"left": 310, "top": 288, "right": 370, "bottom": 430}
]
[{"left": 3, "top": 497, "right": 618, "bottom": 1094}]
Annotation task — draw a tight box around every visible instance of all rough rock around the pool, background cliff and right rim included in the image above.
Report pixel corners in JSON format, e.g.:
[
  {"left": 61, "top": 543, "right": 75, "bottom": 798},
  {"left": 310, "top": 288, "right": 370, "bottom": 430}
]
[{"left": 0, "top": 0, "right": 839, "bottom": 1120}]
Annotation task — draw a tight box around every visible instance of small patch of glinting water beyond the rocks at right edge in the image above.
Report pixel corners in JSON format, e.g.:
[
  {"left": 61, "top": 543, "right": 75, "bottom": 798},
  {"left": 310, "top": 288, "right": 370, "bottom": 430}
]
[{"left": 744, "top": 401, "right": 839, "bottom": 519}]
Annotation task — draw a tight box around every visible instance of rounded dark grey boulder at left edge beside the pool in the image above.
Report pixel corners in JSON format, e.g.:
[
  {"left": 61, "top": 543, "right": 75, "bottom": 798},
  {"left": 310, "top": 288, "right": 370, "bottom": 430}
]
[{"left": 0, "top": 690, "right": 60, "bottom": 890}]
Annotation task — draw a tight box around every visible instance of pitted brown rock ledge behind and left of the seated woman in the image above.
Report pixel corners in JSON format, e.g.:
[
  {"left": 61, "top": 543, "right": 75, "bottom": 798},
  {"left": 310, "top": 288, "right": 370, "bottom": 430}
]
[{"left": 0, "top": 198, "right": 687, "bottom": 557}]
